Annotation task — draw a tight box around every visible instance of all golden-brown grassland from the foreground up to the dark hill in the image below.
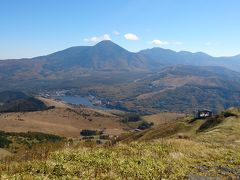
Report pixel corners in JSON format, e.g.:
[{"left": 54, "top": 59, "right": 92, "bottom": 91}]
[{"left": 0, "top": 93, "right": 240, "bottom": 180}]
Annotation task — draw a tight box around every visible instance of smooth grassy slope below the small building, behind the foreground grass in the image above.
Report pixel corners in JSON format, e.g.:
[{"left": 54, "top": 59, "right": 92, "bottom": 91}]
[{"left": 119, "top": 108, "right": 240, "bottom": 144}]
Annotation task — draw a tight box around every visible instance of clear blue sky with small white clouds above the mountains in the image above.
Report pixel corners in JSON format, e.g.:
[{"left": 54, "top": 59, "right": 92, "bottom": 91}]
[{"left": 0, "top": 0, "right": 240, "bottom": 59}]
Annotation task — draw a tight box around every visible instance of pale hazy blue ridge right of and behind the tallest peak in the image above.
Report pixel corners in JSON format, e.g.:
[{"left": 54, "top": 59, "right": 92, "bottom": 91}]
[{"left": 139, "top": 48, "right": 240, "bottom": 72}]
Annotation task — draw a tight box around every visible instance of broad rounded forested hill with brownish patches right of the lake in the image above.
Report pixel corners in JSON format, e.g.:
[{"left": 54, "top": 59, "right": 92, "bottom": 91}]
[{"left": 106, "top": 65, "right": 240, "bottom": 113}]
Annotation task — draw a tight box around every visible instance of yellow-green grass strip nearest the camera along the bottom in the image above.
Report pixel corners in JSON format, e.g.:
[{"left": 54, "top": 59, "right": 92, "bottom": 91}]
[{"left": 0, "top": 139, "right": 240, "bottom": 180}]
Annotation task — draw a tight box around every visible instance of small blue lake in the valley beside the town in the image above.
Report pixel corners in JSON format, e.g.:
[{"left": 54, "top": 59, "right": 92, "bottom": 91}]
[{"left": 57, "top": 96, "right": 108, "bottom": 110}]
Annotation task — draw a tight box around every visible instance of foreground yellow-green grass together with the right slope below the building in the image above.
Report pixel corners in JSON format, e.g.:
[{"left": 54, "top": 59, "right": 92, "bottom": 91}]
[{"left": 0, "top": 109, "right": 240, "bottom": 179}]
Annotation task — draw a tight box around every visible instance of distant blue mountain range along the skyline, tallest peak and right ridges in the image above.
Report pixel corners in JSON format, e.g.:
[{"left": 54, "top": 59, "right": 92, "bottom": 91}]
[{"left": 0, "top": 41, "right": 240, "bottom": 80}]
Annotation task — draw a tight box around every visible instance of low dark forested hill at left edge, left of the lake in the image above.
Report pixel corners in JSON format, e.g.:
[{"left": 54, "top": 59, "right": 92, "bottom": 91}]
[{"left": 0, "top": 91, "right": 48, "bottom": 112}]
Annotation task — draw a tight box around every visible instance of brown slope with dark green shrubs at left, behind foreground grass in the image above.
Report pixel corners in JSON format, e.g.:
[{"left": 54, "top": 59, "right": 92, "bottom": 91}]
[{"left": 0, "top": 131, "right": 66, "bottom": 163}]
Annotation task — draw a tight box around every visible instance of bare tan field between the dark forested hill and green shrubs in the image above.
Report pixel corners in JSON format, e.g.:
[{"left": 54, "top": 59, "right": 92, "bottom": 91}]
[{"left": 0, "top": 99, "right": 127, "bottom": 137}]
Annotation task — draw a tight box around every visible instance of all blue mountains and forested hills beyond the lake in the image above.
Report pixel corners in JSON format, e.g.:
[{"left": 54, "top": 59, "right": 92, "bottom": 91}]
[{"left": 0, "top": 41, "right": 240, "bottom": 112}]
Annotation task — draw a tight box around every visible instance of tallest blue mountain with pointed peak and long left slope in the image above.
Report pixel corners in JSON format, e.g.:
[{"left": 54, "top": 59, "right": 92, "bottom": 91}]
[{"left": 0, "top": 41, "right": 148, "bottom": 85}]
